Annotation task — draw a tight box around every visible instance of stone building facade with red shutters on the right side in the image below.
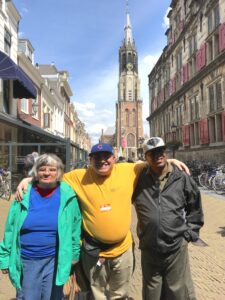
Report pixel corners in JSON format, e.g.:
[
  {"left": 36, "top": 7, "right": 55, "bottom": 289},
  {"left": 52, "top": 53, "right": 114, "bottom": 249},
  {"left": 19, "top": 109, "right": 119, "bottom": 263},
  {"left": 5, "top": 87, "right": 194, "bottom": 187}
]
[{"left": 148, "top": 0, "right": 225, "bottom": 162}]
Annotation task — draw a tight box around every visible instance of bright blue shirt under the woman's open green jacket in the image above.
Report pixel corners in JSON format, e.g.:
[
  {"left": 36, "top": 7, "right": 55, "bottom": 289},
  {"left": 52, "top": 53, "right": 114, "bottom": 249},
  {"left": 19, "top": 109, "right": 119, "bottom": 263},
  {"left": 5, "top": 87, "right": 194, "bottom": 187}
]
[{"left": 20, "top": 187, "right": 60, "bottom": 258}]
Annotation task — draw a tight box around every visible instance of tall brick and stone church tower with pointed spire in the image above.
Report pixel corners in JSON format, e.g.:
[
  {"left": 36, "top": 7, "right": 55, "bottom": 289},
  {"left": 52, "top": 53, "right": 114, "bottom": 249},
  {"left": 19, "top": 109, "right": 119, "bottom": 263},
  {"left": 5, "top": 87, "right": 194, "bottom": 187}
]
[{"left": 116, "top": 4, "right": 143, "bottom": 159}]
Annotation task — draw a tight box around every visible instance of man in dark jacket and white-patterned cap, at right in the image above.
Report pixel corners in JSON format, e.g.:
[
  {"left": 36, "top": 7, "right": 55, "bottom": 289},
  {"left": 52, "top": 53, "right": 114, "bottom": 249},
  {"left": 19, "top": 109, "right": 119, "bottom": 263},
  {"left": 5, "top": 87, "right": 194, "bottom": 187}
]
[{"left": 133, "top": 137, "right": 203, "bottom": 300}]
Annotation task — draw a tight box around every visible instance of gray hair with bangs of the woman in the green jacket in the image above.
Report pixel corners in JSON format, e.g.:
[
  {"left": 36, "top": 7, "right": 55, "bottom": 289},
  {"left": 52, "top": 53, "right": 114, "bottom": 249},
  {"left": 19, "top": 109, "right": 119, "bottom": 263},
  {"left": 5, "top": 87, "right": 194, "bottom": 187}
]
[{"left": 32, "top": 153, "right": 64, "bottom": 182}]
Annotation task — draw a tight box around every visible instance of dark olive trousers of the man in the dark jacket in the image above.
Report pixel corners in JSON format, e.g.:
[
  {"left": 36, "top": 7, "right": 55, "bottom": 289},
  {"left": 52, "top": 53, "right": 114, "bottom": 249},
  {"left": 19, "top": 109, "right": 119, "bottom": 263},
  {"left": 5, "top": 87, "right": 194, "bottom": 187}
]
[{"left": 141, "top": 240, "right": 196, "bottom": 300}]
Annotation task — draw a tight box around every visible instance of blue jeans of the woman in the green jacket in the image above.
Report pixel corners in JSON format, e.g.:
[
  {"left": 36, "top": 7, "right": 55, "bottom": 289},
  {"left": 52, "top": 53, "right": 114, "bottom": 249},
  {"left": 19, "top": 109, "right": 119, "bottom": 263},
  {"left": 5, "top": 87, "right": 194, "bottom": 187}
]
[{"left": 16, "top": 257, "right": 63, "bottom": 300}]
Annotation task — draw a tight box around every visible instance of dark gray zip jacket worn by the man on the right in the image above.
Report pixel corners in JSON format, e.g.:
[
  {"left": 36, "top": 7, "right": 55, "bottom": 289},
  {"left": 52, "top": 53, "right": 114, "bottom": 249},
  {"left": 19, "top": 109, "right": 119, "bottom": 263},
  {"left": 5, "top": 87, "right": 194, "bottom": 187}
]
[{"left": 132, "top": 167, "right": 203, "bottom": 253}]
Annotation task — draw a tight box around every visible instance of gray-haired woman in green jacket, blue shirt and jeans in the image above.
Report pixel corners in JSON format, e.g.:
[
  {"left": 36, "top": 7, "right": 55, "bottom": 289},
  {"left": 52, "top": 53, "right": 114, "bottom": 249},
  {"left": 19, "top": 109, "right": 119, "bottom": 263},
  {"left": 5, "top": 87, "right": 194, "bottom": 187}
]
[{"left": 0, "top": 154, "right": 81, "bottom": 300}]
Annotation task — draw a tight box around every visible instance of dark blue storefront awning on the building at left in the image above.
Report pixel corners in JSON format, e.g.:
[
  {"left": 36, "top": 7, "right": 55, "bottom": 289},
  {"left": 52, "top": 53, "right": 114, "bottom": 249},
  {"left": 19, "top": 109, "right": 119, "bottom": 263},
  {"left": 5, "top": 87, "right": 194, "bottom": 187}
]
[{"left": 0, "top": 51, "right": 37, "bottom": 99}]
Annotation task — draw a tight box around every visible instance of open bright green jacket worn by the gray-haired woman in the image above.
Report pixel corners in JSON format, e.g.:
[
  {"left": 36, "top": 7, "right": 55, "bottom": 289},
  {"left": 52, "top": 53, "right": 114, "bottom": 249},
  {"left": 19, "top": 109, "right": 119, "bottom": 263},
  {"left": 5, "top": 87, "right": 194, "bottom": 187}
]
[{"left": 0, "top": 182, "right": 81, "bottom": 288}]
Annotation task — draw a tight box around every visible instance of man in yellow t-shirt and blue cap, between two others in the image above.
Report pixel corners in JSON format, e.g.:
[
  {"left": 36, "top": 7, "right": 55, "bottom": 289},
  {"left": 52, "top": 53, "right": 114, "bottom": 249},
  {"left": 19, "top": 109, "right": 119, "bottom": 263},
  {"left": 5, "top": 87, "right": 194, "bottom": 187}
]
[{"left": 18, "top": 143, "right": 188, "bottom": 300}]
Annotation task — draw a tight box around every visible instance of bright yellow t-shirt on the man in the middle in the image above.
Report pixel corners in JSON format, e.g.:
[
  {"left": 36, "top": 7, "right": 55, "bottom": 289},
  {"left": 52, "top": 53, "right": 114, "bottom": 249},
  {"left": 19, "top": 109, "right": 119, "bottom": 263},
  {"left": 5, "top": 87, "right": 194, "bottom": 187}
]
[{"left": 63, "top": 163, "right": 145, "bottom": 257}]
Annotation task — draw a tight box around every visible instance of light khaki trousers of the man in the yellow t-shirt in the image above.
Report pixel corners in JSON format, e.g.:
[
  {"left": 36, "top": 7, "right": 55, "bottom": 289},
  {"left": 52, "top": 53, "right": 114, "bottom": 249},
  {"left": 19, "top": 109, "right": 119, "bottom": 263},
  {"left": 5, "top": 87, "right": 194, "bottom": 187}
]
[{"left": 81, "top": 247, "right": 133, "bottom": 300}]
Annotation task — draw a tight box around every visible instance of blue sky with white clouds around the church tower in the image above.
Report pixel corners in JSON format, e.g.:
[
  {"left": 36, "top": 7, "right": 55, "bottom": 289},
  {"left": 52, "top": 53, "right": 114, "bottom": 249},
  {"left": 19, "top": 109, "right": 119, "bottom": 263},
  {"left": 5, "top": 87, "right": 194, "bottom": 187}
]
[{"left": 13, "top": 0, "right": 171, "bottom": 143}]
